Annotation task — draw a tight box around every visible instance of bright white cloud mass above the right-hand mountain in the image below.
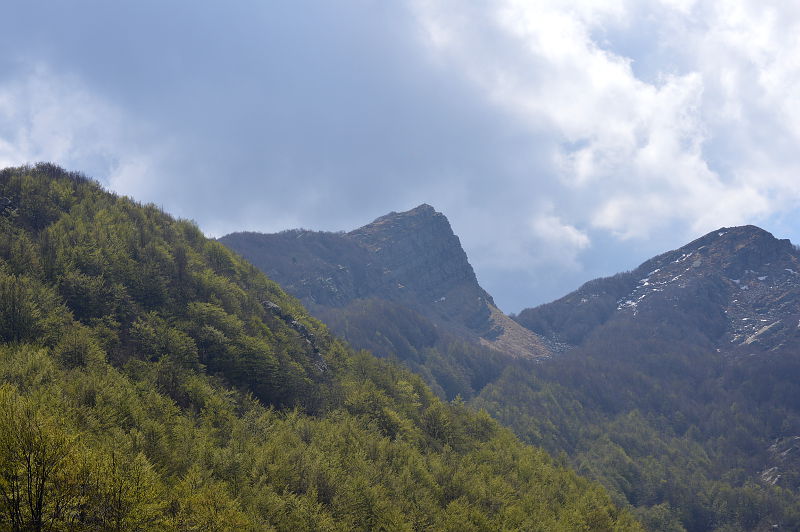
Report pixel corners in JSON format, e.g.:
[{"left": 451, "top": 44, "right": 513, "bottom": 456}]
[{"left": 415, "top": 0, "right": 800, "bottom": 247}]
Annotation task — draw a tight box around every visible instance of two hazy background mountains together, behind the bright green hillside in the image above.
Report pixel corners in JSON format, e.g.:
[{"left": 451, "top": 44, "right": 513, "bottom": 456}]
[{"left": 220, "top": 205, "right": 800, "bottom": 531}]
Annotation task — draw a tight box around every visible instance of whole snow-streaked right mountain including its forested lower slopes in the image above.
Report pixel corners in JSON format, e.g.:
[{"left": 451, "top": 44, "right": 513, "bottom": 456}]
[{"left": 473, "top": 226, "right": 800, "bottom": 531}]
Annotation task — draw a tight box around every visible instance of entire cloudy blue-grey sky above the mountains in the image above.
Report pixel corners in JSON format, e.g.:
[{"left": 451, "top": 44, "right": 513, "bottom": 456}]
[{"left": 0, "top": 0, "right": 800, "bottom": 312}]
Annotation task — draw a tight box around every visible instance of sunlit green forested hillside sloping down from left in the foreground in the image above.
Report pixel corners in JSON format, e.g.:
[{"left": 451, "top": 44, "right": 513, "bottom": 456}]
[{"left": 0, "top": 164, "right": 639, "bottom": 531}]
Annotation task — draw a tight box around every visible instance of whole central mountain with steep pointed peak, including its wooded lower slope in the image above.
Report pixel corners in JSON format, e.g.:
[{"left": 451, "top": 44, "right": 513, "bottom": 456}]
[{"left": 219, "top": 205, "right": 550, "bottom": 397}]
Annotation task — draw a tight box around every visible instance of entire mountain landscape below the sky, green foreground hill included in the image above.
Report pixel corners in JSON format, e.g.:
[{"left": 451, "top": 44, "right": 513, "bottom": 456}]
[{"left": 0, "top": 164, "right": 800, "bottom": 532}]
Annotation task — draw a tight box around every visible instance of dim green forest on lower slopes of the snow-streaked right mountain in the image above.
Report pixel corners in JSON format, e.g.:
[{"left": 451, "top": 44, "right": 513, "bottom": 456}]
[{"left": 474, "top": 317, "right": 800, "bottom": 531}]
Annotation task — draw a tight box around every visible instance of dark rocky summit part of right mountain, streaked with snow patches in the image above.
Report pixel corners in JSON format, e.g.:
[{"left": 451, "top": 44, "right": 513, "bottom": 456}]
[{"left": 517, "top": 222, "right": 800, "bottom": 354}]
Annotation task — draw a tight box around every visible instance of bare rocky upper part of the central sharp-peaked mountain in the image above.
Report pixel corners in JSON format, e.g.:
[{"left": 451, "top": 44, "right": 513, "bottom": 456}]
[{"left": 220, "top": 204, "right": 549, "bottom": 357}]
